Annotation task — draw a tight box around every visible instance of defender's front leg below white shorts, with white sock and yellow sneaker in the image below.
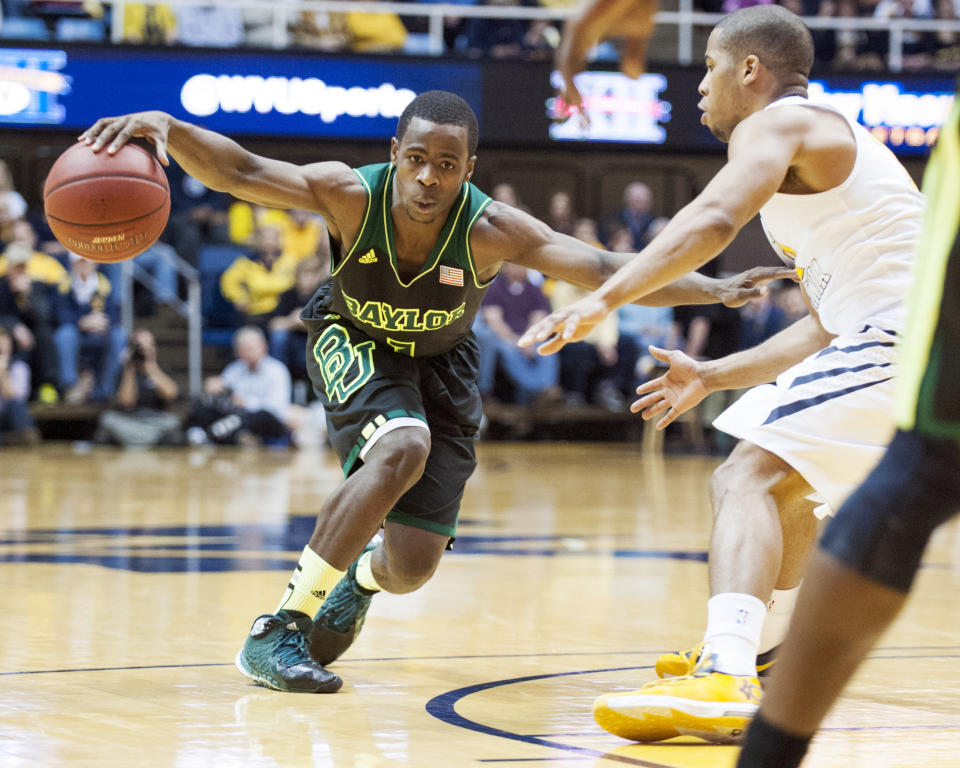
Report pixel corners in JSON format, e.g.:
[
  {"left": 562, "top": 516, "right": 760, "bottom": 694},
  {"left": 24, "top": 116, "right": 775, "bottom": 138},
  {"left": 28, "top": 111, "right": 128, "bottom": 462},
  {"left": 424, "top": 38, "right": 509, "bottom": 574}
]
[{"left": 594, "top": 442, "right": 816, "bottom": 742}]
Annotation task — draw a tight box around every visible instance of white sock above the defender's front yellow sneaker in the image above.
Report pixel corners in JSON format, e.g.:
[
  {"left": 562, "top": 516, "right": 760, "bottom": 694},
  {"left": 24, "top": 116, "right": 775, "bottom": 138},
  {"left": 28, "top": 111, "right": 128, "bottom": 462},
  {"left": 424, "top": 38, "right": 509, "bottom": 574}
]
[{"left": 703, "top": 592, "right": 767, "bottom": 675}]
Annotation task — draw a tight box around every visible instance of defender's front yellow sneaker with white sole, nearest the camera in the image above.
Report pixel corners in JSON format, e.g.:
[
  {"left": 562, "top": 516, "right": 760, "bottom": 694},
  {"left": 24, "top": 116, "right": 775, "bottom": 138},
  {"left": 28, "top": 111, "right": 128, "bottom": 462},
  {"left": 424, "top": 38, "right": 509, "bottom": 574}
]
[{"left": 593, "top": 651, "right": 763, "bottom": 744}]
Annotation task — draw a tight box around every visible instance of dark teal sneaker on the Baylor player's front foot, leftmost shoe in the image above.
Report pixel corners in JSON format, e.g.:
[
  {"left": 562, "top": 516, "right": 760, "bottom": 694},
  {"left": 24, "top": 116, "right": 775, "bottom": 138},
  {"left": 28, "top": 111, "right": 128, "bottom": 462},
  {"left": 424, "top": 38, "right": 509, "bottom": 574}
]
[{"left": 235, "top": 610, "right": 343, "bottom": 693}]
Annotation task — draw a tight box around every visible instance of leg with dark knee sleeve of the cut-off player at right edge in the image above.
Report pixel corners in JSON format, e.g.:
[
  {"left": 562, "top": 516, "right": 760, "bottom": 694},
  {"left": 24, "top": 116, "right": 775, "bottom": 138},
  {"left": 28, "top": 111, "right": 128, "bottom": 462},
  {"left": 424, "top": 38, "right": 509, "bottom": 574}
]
[{"left": 740, "top": 432, "right": 960, "bottom": 768}]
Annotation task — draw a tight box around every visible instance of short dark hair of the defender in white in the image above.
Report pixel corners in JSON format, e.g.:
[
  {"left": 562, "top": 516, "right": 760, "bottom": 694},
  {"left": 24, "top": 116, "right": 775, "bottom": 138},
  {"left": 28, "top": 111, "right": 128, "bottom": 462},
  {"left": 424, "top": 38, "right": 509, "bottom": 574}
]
[{"left": 714, "top": 5, "right": 813, "bottom": 78}]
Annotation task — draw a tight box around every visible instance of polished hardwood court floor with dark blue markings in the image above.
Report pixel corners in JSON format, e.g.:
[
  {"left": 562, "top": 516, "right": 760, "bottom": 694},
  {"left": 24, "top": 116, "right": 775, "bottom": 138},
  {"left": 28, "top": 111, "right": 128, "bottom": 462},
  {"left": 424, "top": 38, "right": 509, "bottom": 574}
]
[{"left": 0, "top": 443, "right": 960, "bottom": 768}]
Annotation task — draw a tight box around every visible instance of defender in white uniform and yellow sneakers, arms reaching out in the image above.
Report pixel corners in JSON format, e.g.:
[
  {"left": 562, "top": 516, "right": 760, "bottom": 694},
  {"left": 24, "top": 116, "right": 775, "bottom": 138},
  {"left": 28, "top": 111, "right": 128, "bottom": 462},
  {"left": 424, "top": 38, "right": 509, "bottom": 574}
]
[{"left": 521, "top": 5, "right": 924, "bottom": 742}]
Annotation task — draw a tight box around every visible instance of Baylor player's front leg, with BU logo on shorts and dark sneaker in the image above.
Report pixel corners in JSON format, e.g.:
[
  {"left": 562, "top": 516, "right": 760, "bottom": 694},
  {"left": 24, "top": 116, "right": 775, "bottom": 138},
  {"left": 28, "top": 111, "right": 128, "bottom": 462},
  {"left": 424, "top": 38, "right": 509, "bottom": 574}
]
[{"left": 237, "top": 314, "right": 430, "bottom": 692}]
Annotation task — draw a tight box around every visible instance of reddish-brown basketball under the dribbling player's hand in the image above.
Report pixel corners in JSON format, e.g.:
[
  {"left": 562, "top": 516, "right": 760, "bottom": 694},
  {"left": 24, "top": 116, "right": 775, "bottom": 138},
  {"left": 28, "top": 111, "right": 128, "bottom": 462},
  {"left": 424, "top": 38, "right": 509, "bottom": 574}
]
[{"left": 43, "top": 144, "right": 170, "bottom": 262}]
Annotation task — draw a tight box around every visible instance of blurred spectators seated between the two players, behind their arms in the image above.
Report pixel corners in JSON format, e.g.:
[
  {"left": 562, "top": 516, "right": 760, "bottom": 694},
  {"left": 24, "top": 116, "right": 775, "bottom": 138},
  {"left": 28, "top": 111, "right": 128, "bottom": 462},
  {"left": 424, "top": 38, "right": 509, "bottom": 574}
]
[{"left": 474, "top": 181, "right": 806, "bottom": 426}]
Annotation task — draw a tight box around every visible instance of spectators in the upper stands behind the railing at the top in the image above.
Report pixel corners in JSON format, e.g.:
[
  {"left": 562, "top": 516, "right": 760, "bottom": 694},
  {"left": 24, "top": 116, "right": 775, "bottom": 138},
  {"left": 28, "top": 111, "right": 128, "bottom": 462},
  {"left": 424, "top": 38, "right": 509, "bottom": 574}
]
[{"left": 0, "top": 0, "right": 960, "bottom": 70}]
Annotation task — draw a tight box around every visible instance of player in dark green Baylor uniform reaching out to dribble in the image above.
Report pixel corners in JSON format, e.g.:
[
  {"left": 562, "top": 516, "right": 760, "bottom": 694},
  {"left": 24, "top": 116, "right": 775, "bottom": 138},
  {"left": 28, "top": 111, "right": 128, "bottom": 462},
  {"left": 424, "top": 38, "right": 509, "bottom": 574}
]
[{"left": 80, "top": 91, "right": 791, "bottom": 693}]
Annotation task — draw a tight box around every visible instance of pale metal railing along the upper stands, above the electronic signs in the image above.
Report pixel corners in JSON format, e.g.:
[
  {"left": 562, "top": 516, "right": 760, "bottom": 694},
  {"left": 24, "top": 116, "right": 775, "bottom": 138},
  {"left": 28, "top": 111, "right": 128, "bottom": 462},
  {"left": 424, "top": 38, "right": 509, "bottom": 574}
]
[{"left": 95, "top": 0, "right": 960, "bottom": 72}]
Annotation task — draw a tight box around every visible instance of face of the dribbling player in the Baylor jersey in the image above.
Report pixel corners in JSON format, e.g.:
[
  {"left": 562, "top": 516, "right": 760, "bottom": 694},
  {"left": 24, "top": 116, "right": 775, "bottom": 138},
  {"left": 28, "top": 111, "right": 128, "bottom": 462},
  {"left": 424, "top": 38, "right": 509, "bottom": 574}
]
[{"left": 390, "top": 117, "right": 476, "bottom": 224}]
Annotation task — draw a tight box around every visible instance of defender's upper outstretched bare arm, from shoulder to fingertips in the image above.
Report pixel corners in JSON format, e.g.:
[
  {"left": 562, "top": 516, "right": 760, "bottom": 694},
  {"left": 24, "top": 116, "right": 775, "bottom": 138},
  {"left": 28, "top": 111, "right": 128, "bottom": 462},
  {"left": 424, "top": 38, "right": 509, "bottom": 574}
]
[{"left": 520, "top": 110, "right": 804, "bottom": 354}]
